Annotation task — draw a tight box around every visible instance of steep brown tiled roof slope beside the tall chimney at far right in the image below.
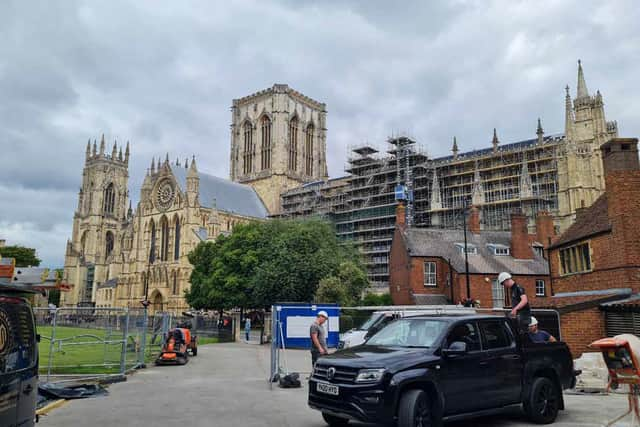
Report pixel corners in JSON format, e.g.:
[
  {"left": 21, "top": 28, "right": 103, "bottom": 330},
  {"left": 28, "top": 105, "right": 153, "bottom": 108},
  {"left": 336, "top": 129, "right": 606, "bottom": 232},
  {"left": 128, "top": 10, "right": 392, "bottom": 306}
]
[{"left": 550, "top": 194, "right": 611, "bottom": 248}]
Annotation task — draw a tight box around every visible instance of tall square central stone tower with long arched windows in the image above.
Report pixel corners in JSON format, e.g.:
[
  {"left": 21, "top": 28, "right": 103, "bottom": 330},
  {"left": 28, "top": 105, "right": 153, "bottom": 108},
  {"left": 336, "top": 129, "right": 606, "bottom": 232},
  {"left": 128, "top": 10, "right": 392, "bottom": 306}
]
[{"left": 231, "top": 84, "right": 328, "bottom": 215}]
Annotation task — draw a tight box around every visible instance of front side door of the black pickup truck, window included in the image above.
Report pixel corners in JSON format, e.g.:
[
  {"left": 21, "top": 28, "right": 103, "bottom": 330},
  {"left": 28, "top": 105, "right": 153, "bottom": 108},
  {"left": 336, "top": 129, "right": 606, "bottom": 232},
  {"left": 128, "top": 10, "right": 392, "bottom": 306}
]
[{"left": 440, "top": 321, "right": 489, "bottom": 414}]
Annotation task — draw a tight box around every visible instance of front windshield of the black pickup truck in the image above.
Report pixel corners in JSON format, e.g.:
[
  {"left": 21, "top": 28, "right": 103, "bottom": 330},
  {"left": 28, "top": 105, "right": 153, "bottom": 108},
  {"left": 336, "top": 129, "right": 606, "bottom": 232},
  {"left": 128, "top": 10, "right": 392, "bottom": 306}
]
[{"left": 367, "top": 318, "right": 447, "bottom": 348}]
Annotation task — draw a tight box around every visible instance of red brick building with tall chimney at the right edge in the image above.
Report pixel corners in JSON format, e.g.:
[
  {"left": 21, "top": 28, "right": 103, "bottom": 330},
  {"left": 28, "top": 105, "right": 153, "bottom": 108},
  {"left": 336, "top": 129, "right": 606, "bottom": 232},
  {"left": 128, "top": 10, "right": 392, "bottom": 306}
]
[{"left": 533, "top": 138, "right": 640, "bottom": 357}]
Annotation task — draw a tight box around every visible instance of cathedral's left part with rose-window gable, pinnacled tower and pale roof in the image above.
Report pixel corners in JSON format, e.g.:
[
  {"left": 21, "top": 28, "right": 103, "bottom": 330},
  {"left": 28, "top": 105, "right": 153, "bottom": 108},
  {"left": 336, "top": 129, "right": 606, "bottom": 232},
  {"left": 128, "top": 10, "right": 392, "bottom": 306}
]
[{"left": 61, "top": 144, "right": 267, "bottom": 313}]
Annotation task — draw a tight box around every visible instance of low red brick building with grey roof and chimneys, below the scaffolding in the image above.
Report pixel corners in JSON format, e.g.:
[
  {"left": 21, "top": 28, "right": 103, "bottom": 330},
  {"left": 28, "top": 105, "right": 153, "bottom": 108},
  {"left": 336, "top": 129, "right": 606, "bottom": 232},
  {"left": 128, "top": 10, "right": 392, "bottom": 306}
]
[{"left": 389, "top": 205, "right": 554, "bottom": 308}]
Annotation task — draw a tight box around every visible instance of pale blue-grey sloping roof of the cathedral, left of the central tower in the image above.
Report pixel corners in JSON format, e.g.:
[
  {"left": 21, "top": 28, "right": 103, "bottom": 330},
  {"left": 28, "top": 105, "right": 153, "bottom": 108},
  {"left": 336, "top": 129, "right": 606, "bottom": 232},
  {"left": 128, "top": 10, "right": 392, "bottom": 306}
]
[{"left": 171, "top": 166, "right": 268, "bottom": 218}]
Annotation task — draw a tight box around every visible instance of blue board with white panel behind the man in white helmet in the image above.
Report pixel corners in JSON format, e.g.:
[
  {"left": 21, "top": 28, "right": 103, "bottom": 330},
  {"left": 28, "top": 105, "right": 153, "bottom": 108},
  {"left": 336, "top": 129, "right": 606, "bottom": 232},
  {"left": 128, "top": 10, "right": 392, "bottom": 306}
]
[{"left": 274, "top": 303, "right": 340, "bottom": 349}]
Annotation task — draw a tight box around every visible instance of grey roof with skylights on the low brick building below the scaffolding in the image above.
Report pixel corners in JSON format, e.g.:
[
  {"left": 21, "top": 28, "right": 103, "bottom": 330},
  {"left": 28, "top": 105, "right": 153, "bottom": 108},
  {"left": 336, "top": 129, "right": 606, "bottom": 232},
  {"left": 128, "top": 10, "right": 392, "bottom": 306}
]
[{"left": 402, "top": 228, "right": 549, "bottom": 276}]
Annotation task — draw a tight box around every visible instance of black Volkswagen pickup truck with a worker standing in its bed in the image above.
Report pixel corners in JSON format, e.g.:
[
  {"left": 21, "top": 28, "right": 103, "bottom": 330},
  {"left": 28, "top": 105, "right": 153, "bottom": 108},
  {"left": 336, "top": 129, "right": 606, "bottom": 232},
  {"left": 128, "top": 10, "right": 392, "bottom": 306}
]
[{"left": 309, "top": 315, "right": 576, "bottom": 427}]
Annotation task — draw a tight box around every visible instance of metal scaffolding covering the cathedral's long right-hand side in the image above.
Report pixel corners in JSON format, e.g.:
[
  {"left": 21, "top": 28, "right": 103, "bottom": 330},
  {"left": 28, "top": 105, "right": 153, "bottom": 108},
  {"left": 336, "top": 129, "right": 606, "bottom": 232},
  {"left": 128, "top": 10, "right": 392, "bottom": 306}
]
[{"left": 281, "top": 136, "right": 564, "bottom": 291}]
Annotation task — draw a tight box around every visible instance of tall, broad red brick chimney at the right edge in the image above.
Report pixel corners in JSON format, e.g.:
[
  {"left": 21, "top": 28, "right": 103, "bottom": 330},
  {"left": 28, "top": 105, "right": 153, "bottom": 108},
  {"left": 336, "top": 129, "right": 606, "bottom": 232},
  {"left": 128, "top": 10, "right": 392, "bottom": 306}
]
[{"left": 600, "top": 138, "right": 640, "bottom": 265}]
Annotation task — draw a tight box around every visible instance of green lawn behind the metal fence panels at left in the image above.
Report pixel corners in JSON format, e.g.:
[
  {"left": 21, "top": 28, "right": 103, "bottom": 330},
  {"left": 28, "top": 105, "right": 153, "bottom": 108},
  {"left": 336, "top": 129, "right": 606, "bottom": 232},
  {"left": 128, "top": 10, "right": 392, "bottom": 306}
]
[{"left": 38, "top": 326, "right": 218, "bottom": 374}]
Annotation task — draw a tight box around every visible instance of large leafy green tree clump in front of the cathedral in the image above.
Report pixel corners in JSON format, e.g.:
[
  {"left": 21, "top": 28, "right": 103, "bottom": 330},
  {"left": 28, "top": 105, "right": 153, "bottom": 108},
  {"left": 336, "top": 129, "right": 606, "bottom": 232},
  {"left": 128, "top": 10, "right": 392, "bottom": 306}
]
[{"left": 186, "top": 219, "right": 366, "bottom": 309}]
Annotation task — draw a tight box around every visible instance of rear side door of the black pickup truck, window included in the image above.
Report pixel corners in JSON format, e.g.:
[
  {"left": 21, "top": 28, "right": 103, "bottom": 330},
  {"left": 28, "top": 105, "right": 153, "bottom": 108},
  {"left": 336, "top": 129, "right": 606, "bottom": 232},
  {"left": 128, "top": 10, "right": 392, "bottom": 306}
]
[{"left": 479, "top": 319, "right": 522, "bottom": 406}]
